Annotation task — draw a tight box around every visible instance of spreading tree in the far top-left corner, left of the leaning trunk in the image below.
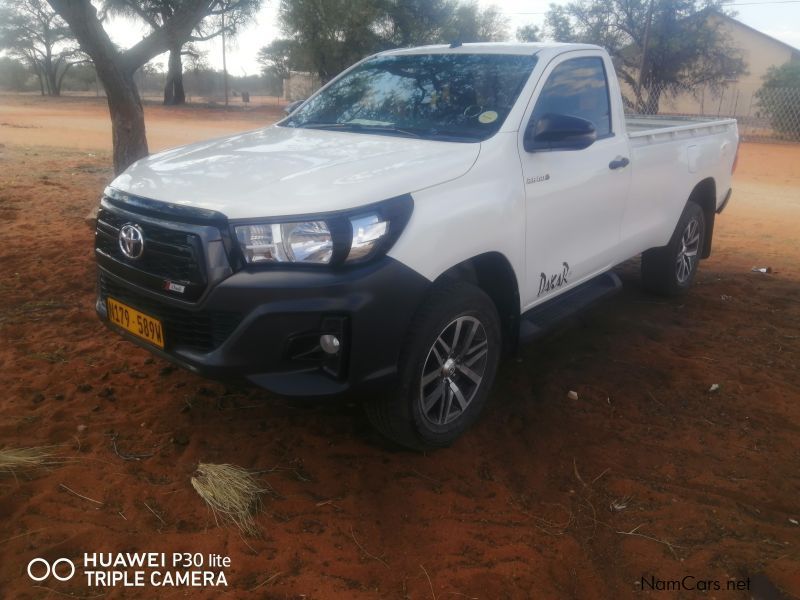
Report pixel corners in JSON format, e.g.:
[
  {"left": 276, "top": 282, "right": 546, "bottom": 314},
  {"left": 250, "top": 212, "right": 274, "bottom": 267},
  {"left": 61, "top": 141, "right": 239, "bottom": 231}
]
[{"left": 0, "top": 0, "right": 84, "bottom": 96}]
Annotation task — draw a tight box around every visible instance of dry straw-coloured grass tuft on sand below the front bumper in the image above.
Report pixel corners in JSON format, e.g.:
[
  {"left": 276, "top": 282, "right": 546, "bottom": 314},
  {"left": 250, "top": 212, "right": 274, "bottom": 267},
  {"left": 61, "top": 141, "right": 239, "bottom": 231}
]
[{"left": 191, "top": 463, "right": 269, "bottom": 535}]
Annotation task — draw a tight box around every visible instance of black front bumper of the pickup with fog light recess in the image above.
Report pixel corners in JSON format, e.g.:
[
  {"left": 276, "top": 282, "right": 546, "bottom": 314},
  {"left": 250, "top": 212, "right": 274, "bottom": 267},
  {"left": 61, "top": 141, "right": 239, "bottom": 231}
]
[{"left": 96, "top": 257, "right": 430, "bottom": 396}]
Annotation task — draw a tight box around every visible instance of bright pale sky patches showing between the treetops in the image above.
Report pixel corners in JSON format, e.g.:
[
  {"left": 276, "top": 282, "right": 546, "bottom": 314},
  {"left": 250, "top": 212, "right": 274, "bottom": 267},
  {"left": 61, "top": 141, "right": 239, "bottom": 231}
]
[{"left": 104, "top": 0, "right": 800, "bottom": 76}]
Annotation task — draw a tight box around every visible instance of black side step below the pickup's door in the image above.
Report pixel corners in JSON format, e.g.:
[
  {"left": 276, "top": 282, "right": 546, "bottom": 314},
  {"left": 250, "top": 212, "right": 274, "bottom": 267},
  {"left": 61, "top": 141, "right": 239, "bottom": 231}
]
[{"left": 519, "top": 272, "right": 622, "bottom": 342}]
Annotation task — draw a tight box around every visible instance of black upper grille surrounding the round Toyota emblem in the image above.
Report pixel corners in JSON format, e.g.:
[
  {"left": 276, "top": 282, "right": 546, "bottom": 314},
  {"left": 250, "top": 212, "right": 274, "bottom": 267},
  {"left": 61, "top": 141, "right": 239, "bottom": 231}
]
[{"left": 96, "top": 209, "right": 206, "bottom": 286}]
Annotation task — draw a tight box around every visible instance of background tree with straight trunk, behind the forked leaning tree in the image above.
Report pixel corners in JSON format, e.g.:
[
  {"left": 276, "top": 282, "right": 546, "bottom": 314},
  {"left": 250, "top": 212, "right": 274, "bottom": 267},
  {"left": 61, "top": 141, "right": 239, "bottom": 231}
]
[{"left": 105, "top": 0, "right": 263, "bottom": 105}]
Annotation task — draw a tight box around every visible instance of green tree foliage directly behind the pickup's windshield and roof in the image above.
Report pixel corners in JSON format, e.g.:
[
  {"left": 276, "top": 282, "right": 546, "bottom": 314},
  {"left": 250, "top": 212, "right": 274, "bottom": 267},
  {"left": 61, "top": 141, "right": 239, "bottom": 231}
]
[{"left": 276, "top": 0, "right": 507, "bottom": 81}]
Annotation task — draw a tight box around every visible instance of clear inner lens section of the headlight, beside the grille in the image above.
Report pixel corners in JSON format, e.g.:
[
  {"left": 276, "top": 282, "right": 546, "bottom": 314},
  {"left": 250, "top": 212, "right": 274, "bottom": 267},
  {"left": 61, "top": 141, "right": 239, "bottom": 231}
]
[{"left": 236, "top": 221, "right": 333, "bottom": 265}]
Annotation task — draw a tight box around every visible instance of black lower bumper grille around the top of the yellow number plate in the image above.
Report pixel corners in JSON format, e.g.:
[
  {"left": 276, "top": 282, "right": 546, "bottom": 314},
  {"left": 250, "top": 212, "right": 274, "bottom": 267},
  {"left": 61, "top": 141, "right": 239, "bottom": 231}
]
[{"left": 99, "top": 272, "right": 242, "bottom": 352}]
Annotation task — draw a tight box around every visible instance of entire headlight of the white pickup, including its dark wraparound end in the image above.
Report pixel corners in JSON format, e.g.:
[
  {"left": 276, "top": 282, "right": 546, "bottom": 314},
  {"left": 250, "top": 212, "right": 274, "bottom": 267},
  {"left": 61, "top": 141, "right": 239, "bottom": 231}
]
[{"left": 234, "top": 195, "right": 414, "bottom": 265}]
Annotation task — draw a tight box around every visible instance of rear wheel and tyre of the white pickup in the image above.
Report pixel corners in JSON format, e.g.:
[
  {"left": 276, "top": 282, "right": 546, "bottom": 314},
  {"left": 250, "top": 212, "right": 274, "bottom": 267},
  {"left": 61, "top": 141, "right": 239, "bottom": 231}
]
[{"left": 642, "top": 201, "right": 706, "bottom": 296}]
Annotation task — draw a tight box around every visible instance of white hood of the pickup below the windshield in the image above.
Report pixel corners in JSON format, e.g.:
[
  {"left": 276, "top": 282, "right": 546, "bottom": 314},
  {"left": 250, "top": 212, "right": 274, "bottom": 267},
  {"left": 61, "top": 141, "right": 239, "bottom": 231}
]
[{"left": 111, "top": 125, "right": 480, "bottom": 219}]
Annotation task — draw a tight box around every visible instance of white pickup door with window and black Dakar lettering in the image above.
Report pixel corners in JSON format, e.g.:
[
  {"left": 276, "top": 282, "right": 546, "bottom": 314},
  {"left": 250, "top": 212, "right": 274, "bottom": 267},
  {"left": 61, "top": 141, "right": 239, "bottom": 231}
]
[{"left": 519, "top": 51, "right": 631, "bottom": 310}]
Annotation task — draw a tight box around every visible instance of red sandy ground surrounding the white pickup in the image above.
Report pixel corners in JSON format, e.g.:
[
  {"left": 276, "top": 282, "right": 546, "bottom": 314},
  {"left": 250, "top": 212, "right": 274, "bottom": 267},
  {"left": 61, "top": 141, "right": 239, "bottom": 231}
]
[{"left": 0, "top": 98, "right": 800, "bottom": 600}]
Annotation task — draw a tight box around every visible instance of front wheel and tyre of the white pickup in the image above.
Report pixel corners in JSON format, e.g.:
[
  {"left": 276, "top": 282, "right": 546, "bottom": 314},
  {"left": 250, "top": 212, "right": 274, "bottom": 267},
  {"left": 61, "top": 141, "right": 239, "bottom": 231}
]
[{"left": 364, "top": 281, "right": 502, "bottom": 450}]
